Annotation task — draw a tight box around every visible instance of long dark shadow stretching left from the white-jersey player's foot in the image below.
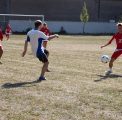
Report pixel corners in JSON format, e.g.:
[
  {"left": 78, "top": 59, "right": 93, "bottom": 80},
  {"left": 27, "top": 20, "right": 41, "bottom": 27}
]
[{"left": 1, "top": 80, "right": 39, "bottom": 89}]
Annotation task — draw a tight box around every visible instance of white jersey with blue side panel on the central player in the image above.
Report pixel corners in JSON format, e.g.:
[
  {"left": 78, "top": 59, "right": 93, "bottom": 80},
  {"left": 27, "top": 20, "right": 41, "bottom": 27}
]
[{"left": 26, "top": 29, "right": 49, "bottom": 56}]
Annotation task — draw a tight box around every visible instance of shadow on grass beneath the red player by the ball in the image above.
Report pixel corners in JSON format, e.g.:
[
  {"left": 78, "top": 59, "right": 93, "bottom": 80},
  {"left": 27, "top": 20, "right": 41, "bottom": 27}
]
[{"left": 94, "top": 74, "right": 122, "bottom": 82}]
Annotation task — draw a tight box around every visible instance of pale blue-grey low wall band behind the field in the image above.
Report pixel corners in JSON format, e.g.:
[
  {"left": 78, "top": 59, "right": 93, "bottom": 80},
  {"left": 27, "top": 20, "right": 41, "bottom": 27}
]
[{"left": 10, "top": 20, "right": 116, "bottom": 34}]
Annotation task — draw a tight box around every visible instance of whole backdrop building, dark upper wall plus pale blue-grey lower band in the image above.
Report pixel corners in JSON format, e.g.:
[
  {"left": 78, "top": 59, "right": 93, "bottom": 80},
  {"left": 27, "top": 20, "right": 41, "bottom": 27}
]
[{"left": 0, "top": 0, "right": 122, "bottom": 34}]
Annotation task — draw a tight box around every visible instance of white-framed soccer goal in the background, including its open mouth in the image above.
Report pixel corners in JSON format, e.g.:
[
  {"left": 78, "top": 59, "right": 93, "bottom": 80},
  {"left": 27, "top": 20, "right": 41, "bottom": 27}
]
[{"left": 0, "top": 14, "right": 44, "bottom": 32}]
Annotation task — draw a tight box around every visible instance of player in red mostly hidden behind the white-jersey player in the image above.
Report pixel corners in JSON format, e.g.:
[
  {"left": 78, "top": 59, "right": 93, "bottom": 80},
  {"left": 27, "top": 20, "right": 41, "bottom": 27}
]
[{"left": 40, "top": 23, "right": 51, "bottom": 72}]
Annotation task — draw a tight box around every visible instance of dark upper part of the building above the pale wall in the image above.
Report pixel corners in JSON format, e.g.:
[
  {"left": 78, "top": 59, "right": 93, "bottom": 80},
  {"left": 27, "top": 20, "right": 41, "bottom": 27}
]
[{"left": 0, "top": 0, "right": 122, "bottom": 21}]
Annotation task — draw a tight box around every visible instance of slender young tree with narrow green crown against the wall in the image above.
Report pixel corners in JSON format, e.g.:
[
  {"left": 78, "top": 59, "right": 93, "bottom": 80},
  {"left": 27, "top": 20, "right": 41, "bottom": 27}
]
[{"left": 80, "top": 1, "right": 89, "bottom": 34}]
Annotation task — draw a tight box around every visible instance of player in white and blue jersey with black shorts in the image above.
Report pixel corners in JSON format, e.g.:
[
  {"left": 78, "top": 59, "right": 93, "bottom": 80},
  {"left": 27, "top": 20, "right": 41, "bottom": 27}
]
[{"left": 22, "top": 20, "right": 58, "bottom": 81}]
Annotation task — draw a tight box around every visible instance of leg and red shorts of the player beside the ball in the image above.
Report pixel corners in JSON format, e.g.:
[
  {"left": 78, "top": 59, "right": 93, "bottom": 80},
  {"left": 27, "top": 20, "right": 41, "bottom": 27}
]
[{"left": 105, "top": 51, "right": 122, "bottom": 75}]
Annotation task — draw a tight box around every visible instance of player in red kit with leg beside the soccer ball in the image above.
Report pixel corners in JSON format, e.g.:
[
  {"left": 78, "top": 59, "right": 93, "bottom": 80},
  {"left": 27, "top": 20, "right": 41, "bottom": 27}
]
[{"left": 101, "top": 23, "right": 122, "bottom": 75}]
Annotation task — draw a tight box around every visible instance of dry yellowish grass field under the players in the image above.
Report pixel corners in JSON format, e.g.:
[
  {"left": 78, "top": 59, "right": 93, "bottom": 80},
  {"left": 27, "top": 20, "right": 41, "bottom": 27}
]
[{"left": 0, "top": 35, "right": 122, "bottom": 120}]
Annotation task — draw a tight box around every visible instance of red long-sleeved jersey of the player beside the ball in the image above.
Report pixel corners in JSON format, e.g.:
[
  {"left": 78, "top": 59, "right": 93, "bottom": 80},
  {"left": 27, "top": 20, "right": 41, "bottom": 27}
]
[{"left": 109, "top": 33, "right": 122, "bottom": 49}]
